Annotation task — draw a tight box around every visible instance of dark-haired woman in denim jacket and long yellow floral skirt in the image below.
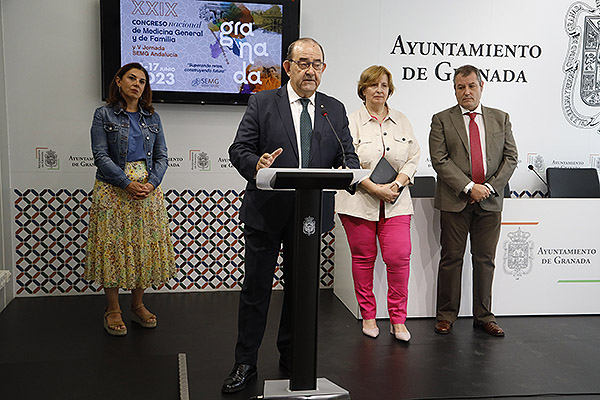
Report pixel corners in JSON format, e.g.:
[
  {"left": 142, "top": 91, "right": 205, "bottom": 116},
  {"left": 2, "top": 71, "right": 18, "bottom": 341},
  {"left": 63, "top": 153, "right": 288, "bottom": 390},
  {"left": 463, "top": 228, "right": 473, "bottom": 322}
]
[{"left": 84, "top": 63, "right": 175, "bottom": 336}]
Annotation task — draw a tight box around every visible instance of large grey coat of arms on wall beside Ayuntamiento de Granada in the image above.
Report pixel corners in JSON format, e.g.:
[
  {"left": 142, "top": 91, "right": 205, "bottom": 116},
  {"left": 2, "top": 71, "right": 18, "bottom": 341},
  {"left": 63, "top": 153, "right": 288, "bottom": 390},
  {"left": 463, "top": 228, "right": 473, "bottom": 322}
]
[{"left": 562, "top": 0, "right": 600, "bottom": 131}]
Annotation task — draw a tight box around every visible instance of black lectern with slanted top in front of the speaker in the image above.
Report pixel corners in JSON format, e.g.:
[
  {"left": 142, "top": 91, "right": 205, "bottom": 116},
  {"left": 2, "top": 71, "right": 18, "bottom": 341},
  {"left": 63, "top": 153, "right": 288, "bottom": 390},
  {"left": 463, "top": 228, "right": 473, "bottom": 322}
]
[{"left": 256, "top": 168, "right": 370, "bottom": 400}]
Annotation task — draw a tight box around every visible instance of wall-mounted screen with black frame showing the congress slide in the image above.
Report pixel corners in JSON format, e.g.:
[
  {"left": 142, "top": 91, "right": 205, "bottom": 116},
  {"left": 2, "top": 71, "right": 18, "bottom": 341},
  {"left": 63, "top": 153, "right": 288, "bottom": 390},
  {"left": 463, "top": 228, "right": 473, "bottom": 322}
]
[{"left": 101, "top": 0, "right": 299, "bottom": 104}]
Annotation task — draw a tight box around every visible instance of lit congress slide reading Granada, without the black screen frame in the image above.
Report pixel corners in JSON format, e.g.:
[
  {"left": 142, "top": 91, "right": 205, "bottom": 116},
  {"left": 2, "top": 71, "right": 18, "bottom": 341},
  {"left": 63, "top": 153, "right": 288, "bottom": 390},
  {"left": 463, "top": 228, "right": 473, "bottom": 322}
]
[{"left": 121, "top": 0, "right": 283, "bottom": 93}]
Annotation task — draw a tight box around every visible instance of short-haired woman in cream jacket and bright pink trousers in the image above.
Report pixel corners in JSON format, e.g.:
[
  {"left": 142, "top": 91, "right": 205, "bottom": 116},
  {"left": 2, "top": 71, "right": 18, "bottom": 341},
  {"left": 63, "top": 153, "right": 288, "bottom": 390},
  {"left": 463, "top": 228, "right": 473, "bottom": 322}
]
[{"left": 336, "top": 65, "right": 421, "bottom": 341}]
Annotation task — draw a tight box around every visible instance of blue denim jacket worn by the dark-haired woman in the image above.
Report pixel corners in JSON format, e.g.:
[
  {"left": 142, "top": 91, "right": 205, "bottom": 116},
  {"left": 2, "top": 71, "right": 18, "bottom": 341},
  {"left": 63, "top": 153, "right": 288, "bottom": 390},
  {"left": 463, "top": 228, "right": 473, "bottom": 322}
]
[{"left": 91, "top": 105, "right": 167, "bottom": 189}]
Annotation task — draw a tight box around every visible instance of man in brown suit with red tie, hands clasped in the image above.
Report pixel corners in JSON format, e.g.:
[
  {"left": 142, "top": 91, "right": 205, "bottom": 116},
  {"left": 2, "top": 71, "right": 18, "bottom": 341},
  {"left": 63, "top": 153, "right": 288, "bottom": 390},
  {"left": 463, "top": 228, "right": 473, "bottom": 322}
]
[{"left": 429, "top": 65, "right": 518, "bottom": 336}]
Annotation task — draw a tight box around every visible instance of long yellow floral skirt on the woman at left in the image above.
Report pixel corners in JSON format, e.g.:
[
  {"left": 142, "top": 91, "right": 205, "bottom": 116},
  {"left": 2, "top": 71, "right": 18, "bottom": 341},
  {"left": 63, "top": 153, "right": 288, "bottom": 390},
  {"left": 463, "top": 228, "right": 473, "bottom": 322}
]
[{"left": 84, "top": 161, "right": 176, "bottom": 289}]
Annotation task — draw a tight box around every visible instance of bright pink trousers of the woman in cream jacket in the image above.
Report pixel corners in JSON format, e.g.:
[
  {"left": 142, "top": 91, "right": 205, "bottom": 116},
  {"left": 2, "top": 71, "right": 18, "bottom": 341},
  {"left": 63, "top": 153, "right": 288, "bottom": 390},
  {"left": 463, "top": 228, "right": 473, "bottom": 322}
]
[{"left": 340, "top": 214, "right": 411, "bottom": 324}]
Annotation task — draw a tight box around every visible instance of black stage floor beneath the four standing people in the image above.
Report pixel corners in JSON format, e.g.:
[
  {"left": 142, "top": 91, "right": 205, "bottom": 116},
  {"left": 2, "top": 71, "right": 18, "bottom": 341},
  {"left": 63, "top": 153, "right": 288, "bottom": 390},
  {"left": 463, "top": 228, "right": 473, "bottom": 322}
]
[{"left": 0, "top": 290, "right": 600, "bottom": 400}]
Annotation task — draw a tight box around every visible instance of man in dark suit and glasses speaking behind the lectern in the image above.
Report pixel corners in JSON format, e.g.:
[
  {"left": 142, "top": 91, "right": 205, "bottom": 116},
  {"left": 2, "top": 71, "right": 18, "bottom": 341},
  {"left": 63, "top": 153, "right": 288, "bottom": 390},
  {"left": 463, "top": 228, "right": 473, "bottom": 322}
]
[{"left": 222, "top": 38, "right": 360, "bottom": 393}]
